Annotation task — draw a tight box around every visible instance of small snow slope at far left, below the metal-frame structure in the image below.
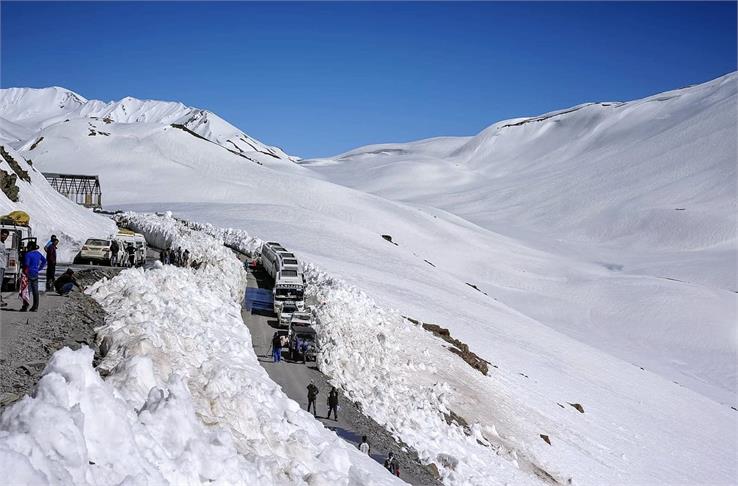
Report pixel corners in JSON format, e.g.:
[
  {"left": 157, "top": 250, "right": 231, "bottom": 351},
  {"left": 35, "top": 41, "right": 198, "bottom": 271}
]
[{"left": 0, "top": 145, "right": 116, "bottom": 262}]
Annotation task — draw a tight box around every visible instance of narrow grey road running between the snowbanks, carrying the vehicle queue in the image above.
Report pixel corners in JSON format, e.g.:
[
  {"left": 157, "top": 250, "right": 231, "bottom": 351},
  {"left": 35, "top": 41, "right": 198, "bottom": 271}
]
[{"left": 241, "top": 270, "right": 441, "bottom": 485}]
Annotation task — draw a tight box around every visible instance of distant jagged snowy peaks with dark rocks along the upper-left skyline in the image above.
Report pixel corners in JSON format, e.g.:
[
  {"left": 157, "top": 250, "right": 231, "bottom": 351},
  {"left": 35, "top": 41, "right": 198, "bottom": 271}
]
[{"left": 0, "top": 87, "right": 290, "bottom": 169}]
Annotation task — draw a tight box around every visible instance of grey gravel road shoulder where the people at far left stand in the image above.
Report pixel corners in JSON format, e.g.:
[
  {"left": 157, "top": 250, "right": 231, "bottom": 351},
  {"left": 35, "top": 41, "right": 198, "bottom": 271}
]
[{"left": 0, "top": 268, "right": 120, "bottom": 409}]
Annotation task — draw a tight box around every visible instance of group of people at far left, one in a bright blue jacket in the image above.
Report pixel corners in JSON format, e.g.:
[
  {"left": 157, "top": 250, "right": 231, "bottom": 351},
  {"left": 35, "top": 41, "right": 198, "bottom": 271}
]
[{"left": 0, "top": 229, "right": 79, "bottom": 312}]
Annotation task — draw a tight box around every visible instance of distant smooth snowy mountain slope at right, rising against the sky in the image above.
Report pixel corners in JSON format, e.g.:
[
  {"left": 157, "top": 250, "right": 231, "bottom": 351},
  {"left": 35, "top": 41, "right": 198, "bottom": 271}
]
[{"left": 302, "top": 73, "right": 738, "bottom": 290}]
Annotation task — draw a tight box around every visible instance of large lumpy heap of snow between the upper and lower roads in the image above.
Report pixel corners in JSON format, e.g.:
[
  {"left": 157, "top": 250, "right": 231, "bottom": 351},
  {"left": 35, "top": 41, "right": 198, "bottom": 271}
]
[{"left": 0, "top": 215, "right": 401, "bottom": 486}]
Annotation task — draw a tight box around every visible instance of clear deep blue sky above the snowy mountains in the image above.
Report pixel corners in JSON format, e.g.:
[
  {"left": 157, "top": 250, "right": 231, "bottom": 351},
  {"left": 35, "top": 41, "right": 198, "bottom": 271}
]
[{"left": 0, "top": 1, "right": 736, "bottom": 156}]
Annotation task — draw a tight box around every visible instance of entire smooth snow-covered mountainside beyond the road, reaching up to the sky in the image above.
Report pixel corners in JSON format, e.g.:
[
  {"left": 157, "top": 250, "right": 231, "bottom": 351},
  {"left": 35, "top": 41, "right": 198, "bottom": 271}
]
[{"left": 0, "top": 73, "right": 738, "bottom": 484}]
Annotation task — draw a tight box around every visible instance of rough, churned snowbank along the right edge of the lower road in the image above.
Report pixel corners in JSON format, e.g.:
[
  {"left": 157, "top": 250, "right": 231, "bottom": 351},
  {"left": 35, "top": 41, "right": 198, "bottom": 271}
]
[{"left": 186, "top": 214, "right": 542, "bottom": 486}]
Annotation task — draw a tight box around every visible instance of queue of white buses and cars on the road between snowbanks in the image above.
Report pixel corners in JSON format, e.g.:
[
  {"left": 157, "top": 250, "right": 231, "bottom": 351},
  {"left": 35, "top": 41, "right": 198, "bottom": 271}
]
[{"left": 258, "top": 241, "right": 318, "bottom": 362}]
